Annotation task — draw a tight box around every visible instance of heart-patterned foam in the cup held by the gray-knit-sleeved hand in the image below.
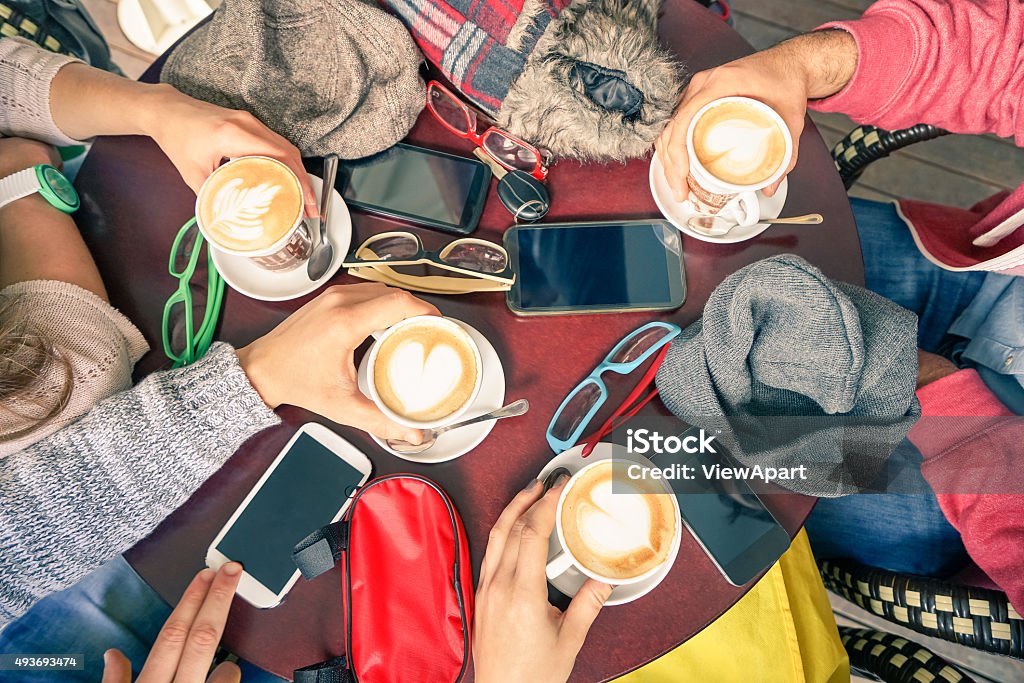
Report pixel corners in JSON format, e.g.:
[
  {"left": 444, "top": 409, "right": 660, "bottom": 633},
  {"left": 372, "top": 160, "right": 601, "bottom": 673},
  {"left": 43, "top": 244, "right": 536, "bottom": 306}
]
[{"left": 374, "top": 323, "right": 479, "bottom": 422}]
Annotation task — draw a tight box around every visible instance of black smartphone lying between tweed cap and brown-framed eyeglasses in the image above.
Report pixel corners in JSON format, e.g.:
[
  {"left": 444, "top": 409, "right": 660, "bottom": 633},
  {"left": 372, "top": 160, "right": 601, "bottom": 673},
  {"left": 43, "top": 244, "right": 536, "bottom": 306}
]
[{"left": 342, "top": 142, "right": 490, "bottom": 234}]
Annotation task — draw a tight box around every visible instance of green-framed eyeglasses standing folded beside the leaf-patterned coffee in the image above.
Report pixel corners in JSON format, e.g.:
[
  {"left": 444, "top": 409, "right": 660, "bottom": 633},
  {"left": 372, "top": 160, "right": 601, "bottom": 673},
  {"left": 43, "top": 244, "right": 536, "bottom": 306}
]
[{"left": 163, "top": 218, "right": 224, "bottom": 368}]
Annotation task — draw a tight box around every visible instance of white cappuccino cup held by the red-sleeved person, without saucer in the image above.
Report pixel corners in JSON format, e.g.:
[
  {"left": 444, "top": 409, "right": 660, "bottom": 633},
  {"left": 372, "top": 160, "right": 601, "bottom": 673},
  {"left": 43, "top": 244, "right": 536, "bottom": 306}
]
[{"left": 686, "top": 97, "right": 793, "bottom": 226}]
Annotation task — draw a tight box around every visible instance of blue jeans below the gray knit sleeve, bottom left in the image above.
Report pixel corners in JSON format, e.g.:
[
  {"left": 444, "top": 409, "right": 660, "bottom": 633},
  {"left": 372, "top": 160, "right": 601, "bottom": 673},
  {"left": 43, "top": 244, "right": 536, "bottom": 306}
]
[{"left": 0, "top": 557, "right": 282, "bottom": 683}]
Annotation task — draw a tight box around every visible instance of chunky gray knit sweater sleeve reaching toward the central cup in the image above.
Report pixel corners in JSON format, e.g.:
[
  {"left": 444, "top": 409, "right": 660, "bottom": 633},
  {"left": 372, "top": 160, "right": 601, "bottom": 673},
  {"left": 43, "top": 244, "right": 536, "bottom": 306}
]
[{"left": 0, "top": 344, "right": 280, "bottom": 628}]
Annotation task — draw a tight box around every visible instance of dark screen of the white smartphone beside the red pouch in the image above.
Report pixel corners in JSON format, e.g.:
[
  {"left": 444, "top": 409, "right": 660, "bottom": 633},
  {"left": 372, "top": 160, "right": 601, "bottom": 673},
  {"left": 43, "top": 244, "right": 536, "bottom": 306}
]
[{"left": 216, "top": 432, "right": 367, "bottom": 594}]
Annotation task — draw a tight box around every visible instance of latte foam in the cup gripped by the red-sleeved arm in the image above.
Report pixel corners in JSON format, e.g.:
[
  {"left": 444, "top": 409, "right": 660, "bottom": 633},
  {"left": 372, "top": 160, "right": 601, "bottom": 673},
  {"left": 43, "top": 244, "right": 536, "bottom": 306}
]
[{"left": 693, "top": 101, "right": 786, "bottom": 185}]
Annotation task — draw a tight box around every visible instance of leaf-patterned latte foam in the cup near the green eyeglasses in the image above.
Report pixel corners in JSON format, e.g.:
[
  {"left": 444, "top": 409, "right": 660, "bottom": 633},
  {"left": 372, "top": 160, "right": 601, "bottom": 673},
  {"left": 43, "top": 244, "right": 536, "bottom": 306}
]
[{"left": 196, "top": 157, "right": 302, "bottom": 252}]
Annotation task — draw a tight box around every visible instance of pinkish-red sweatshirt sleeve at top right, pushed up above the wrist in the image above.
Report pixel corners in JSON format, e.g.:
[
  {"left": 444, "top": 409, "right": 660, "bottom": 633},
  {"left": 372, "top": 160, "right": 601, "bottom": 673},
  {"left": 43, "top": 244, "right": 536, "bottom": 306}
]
[{"left": 812, "top": 0, "right": 1024, "bottom": 145}]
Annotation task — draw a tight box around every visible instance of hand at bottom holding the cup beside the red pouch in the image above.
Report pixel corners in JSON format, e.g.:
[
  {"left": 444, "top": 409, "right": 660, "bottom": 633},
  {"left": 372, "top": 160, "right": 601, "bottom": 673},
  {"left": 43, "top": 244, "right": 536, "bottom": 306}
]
[{"left": 473, "top": 476, "right": 611, "bottom": 683}]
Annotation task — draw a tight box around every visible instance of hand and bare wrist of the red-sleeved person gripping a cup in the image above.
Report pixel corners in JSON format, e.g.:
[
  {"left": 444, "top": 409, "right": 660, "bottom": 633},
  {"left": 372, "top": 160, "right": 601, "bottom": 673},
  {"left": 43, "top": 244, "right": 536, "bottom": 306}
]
[{"left": 655, "top": 30, "right": 857, "bottom": 202}]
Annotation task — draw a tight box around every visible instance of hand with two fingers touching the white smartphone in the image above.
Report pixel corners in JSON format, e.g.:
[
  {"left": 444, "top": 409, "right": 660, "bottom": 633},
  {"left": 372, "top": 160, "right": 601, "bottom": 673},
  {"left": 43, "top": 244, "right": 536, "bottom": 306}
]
[{"left": 102, "top": 562, "right": 242, "bottom": 683}]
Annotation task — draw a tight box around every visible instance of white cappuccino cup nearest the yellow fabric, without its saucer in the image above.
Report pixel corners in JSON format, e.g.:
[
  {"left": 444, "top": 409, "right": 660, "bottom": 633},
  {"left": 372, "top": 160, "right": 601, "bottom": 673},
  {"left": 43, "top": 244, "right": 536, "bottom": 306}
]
[{"left": 546, "top": 459, "right": 682, "bottom": 586}]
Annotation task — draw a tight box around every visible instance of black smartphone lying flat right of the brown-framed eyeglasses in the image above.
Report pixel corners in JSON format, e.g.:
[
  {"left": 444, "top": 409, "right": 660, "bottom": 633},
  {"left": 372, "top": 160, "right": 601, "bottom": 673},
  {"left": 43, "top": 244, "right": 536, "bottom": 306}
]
[{"left": 505, "top": 220, "right": 686, "bottom": 315}]
